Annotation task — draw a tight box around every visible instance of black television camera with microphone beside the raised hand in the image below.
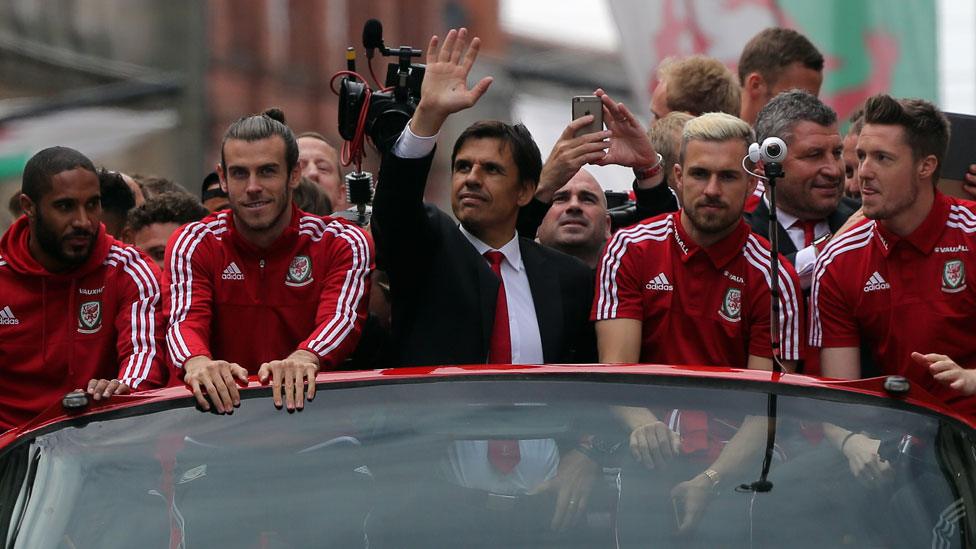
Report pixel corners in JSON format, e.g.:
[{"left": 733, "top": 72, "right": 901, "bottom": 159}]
[{"left": 339, "top": 19, "right": 425, "bottom": 153}]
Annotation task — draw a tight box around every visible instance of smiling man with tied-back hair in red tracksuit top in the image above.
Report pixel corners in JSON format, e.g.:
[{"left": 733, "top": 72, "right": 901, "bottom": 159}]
[{"left": 165, "top": 109, "right": 373, "bottom": 413}]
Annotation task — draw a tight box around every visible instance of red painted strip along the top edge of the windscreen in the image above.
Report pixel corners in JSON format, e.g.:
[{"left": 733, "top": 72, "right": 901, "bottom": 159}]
[{"left": 0, "top": 364, "right": 976, "bottom": 448}]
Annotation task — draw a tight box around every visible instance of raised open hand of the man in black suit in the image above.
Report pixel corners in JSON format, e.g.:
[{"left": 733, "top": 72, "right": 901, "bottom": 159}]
[{"left": 410, "top": 28, "right": 492, "bottom": 137}]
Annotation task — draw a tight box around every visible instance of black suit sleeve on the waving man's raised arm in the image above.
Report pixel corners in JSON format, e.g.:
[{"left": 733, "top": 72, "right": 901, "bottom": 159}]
[{"left": 371, "top": 152, "right": 435, "bottom": 276}]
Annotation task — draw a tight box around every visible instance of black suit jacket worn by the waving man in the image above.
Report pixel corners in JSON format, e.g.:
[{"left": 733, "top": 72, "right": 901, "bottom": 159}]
[{"left": 372, "top": 153, "right": 596, "bottom": 366}]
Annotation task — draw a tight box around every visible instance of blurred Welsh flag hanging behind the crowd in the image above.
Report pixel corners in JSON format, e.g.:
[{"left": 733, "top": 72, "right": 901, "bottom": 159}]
[{"left": 609, "top": 0, "right": 938, "bottom": 124}]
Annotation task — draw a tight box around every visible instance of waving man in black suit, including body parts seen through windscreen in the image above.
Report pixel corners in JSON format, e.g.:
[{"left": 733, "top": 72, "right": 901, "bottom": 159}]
[{"left": 371, "top": 25, "right": 597, "bottom": 546}]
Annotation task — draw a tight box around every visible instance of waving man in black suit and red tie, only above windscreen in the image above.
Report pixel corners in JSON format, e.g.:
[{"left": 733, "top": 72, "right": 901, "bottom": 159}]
[{"left": 373, "top": 31, "right": 592, "bottom": 365}]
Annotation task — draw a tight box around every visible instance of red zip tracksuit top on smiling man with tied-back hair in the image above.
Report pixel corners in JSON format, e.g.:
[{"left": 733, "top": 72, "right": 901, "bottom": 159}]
[{"left": 163, "top": 207, "right": 373, "bottom": 374}]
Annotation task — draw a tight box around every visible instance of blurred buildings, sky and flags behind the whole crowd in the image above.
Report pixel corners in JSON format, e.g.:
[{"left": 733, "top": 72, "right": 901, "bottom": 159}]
[{"left": 0, "top": 0, "right": 976, "bottom": 227}]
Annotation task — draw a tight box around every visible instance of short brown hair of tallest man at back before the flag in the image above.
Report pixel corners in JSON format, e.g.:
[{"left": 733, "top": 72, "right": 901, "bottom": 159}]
[{"left": 739, "top": 27, "right": 824, "bottom": 86}]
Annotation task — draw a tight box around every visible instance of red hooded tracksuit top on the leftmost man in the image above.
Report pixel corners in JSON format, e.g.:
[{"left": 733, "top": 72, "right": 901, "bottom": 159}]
[{"left": 0, "top": 216, "right": 165, "bottom": 431}]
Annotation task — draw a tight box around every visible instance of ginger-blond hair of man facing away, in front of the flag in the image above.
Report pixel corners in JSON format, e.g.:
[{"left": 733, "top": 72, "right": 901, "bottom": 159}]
[{"left": 657, "top": 55, "right": 742, "bottom": 116}]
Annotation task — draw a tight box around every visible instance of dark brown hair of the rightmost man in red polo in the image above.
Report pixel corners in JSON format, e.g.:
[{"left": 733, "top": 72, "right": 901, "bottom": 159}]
[{"left": 864, "top": 93, "right": 950, "bottom": 182}]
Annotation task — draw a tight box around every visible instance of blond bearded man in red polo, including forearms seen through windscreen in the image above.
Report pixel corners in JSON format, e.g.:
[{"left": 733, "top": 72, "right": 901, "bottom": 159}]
[{"left": 592, "top": 113, "right": 802, "bottom": 531}]
